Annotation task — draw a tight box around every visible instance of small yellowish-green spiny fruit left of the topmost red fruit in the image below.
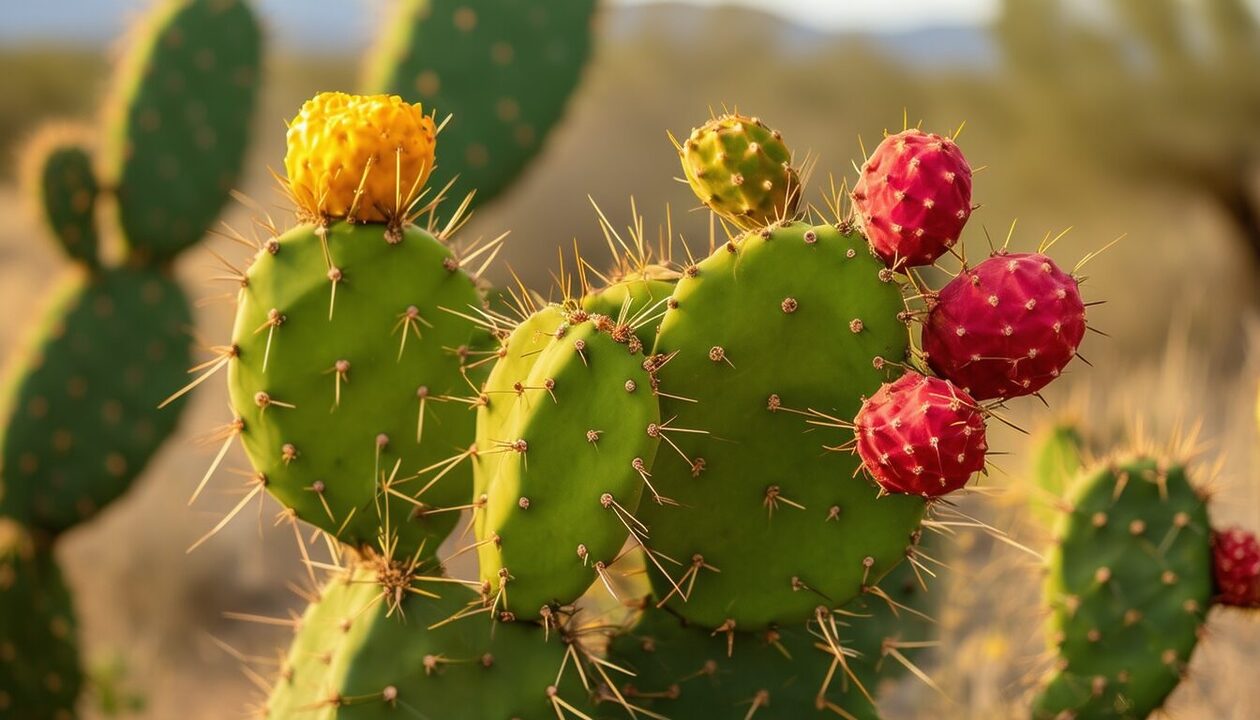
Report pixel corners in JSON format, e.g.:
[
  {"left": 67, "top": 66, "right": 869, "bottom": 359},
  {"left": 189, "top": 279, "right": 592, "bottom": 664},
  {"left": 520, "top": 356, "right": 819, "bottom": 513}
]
[{"left": 678, "top": 115, "right": 800, "bottom": 229}]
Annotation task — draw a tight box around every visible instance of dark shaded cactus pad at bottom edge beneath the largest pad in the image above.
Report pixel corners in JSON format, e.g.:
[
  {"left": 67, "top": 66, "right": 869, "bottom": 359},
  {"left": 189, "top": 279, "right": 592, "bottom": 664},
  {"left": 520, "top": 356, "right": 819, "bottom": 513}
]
[{"left": 609, "top": 609, "right": 879, "bottom": 720}]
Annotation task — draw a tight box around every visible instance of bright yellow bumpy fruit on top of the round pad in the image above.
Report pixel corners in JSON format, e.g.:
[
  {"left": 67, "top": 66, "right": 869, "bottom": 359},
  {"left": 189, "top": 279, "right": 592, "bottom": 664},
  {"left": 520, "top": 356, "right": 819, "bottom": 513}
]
[{"left": 285, "top": 92, "right": 437, "bottom": 222}]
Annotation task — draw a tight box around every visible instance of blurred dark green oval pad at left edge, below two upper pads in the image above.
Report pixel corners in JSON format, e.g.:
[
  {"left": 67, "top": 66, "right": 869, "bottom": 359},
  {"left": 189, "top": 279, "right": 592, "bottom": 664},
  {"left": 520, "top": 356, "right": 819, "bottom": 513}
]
[{"left": 0, "top": 267, "right": 193, "bottom": 533}]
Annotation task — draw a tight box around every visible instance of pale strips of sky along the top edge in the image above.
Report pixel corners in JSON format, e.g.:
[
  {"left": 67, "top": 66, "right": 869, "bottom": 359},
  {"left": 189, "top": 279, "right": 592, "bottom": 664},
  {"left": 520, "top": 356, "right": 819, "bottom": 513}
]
[{"left": 0, "top": 0, "right": 998, "bottom": 47}]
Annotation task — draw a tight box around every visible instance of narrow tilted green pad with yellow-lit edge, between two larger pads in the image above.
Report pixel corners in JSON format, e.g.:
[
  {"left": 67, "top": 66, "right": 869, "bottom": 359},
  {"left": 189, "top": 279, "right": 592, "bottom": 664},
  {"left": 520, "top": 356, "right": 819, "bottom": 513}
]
[{"left": 476, "top": 309, "right": 660, "bottom": 619}]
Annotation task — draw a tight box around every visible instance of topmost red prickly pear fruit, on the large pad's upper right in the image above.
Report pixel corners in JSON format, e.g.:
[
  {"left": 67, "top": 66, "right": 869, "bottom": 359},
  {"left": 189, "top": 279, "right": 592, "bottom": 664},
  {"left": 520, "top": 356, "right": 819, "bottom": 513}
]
[{"left": 853, "top": 129, "right": 971, "bottom": 270}]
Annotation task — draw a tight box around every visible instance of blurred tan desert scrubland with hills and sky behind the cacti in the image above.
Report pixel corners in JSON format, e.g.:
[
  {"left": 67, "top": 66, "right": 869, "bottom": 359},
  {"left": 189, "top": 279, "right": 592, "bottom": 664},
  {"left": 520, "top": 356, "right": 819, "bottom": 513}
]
[{"left": 0, "top": 0, "right": 1260, "bottom": 719}]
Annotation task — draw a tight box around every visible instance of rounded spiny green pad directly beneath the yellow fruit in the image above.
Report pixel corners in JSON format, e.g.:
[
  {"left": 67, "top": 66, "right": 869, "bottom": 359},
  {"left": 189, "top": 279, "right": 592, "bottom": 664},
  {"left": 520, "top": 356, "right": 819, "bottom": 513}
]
[{"left": 228, "top": 222, "right": 481, "bottom": 557}]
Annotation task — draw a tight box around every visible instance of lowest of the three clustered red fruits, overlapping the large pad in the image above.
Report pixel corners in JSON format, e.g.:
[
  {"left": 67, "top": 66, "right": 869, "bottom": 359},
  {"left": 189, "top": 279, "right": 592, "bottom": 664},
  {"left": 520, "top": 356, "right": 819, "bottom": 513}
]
[{"left": 854, "top": 372, "right": 989, "bottom": 498}]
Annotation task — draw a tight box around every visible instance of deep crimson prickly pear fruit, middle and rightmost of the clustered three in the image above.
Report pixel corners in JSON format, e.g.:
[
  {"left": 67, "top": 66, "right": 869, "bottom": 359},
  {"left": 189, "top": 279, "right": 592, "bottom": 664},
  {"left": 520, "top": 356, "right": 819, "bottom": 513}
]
[{"left": 924, "top": 252, "right": 1085, "bottom": 400}]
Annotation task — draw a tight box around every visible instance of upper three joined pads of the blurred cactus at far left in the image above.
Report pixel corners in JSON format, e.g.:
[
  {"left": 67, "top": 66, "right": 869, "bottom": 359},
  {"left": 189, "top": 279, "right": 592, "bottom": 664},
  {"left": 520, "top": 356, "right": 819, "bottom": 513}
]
[{"left": 0, "top": 0, "right": 261, "bottom": 533}]
